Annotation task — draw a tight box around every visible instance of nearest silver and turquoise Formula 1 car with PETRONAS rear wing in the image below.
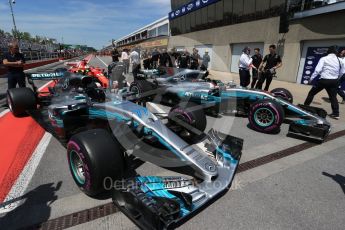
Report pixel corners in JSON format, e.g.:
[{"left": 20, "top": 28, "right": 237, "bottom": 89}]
[{"left": 7, "top": 72, "right": 243, "bottom": 229}]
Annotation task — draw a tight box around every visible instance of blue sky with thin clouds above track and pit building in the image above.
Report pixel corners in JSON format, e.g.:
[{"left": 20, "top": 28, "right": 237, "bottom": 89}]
[{"left": 0, "top": 0, "right": 170, "bottom": 49}]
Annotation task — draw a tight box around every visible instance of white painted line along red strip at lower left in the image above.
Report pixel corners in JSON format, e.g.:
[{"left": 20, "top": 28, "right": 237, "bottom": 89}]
[{"left": 0, "top": 132, "right": 52, "bottom": 213}]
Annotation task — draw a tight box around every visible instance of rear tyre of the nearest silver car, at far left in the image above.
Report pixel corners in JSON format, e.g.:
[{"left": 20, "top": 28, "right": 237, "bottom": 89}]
[{"left": 7, "top": 88, "right": 37, "bottom": 117}]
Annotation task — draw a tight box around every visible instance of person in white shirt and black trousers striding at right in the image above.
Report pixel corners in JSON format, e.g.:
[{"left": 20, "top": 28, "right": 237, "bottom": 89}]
[{"left": 304, "top": 46, "right": 345, "bottom": 119}]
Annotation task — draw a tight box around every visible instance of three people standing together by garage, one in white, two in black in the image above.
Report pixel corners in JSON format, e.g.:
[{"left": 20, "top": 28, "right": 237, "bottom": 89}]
[{"left": 238, "top": 45, "right": 283, "bottom": 91}]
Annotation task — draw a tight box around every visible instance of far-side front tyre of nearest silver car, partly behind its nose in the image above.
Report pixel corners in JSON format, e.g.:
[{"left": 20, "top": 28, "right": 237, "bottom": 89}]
[{"left": 168, "top": 102, "right": 207, "bottom": 132}]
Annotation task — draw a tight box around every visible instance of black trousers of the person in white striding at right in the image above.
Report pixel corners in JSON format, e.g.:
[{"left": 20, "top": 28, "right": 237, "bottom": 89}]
[{"left": 304, "top": 79, "right": 339, "bottom": 115}]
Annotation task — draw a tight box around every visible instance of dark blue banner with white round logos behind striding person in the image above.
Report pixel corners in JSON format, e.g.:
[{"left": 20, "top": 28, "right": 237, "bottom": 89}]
[{"left": 301, "top": 47, "right": 345, "bottom": 90}]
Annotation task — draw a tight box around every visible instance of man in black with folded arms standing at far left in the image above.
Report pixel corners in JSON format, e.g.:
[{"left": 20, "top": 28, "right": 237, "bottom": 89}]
[{"left": 3, "top": 42, "right": 26, "bottom": 89}]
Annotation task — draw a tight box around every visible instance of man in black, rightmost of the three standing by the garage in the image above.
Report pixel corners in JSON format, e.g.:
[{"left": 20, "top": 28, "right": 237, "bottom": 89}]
[{"left": 255, "top": 45, "right": 283, "bottom": 91}]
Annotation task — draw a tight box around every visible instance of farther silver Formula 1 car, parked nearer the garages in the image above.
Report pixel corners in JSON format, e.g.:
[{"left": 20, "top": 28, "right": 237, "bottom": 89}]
[{"left": 129, "top": 69, "right": 331, "bottom": 142}]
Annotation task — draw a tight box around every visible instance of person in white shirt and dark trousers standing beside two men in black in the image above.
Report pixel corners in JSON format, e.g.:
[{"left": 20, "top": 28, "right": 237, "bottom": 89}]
[{"left": 238, "top": 47, "right": 253, "bottom": 87}]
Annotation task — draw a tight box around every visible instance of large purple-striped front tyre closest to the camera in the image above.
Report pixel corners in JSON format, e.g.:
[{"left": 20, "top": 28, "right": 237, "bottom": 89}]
[{"left": 67, "top": 129, "right": 125, "bottom": 196}]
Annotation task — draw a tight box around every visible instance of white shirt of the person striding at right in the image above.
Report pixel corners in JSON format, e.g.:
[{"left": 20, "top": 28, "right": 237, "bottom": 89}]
[{"left": 310, "top": 54, "right": 345, "bottom": 81}]
